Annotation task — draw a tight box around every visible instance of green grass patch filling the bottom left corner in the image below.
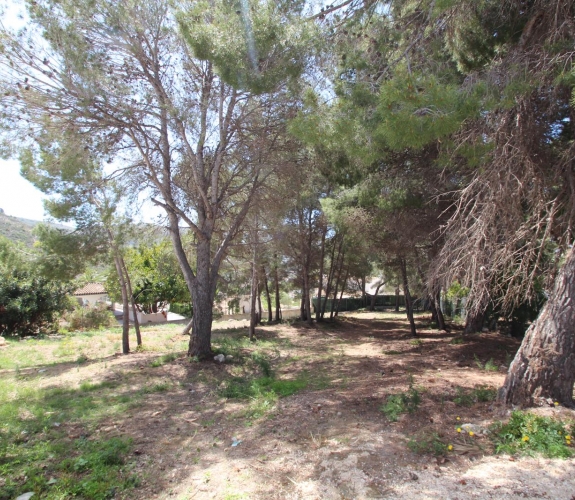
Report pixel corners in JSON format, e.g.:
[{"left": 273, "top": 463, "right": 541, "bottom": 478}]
[{"left": 0, "top": 379, "right": 139, "bottom": 500}]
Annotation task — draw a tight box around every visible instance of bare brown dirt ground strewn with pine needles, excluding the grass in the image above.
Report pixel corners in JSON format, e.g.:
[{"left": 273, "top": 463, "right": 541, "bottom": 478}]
[{"left": 23, "top": 313, "right": 575, "bottom": 500}]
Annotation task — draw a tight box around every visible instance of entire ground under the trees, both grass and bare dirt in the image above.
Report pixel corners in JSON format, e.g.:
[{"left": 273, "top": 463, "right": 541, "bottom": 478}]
[{"left": 0, "top": 312, "right": 575, "bottom": 500}]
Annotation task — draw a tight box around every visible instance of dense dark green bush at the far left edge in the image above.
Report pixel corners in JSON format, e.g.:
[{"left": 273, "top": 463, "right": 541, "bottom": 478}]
[{"left": 0, "top": 270, "right": 71, "bottom": 336}]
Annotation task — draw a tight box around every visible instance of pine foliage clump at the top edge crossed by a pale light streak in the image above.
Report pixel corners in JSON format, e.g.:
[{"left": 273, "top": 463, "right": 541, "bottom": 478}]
[{"left": 176, "top": 0, "right": 315, "bottom": 94}]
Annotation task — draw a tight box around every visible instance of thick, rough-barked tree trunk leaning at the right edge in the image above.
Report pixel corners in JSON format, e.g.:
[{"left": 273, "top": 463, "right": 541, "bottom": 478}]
[{"left": 499, "top": 247, "right": 575, "bottom": 407}]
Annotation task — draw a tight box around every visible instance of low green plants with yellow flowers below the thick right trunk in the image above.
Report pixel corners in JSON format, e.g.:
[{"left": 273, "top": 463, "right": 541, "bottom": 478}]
[{"left": 491, "top": 411, "right": 575, "bottom": 458}]
